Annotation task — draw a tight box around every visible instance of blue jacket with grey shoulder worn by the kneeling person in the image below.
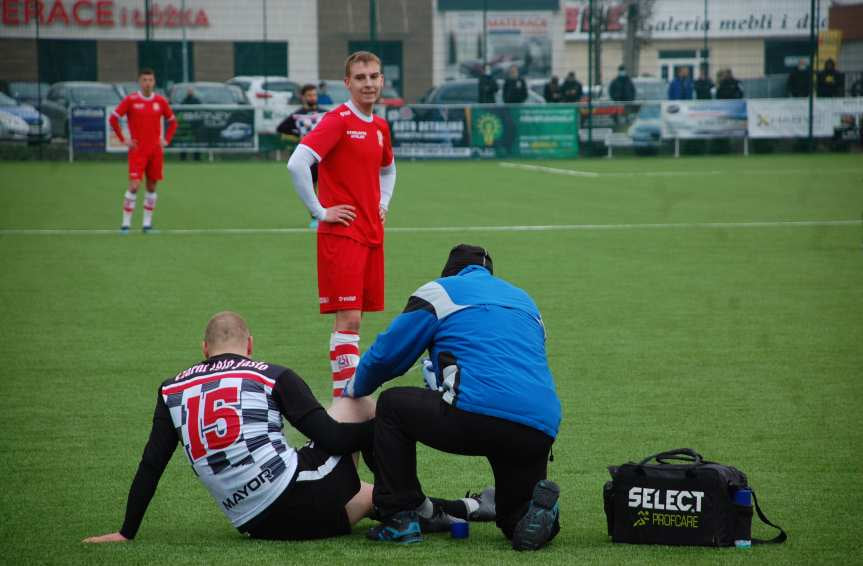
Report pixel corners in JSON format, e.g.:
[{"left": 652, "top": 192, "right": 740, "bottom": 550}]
[{"left": 348, "top": 265, "right": 561, "bottom": 438}]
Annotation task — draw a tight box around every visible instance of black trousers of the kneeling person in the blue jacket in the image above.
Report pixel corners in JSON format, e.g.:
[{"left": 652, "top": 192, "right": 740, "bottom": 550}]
[{"left": 374, "top": 387, "right": 554, "bottom": 538}]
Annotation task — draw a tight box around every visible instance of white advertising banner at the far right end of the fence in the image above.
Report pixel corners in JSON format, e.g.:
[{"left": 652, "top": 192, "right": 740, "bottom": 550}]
[{"left": 747, "top": 98, "right": 863, "bottom": 138}]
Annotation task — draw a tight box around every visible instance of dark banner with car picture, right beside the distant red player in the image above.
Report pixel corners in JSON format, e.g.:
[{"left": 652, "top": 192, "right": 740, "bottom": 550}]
[{"left": 164, "top": 104, "right": 258, "bottom": 151}]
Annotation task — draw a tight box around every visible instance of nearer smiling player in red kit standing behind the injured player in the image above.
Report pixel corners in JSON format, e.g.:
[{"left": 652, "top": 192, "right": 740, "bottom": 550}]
[{"left": 288, "top": 51, "right": 396, "bottom": 410}]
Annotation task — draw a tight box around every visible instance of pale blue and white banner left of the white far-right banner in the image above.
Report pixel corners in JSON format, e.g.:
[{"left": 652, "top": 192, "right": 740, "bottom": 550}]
[{"left": 661, "top": 100, "right": 747, "bottom": 139}]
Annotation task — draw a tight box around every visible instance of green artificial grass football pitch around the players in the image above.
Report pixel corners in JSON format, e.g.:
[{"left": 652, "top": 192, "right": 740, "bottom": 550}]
[{"left": 0, "top": 155, "right": 863, "bottom": 565}]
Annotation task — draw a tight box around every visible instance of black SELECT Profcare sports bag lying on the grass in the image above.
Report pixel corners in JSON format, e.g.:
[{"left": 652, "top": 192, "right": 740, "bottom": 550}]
[{"left": 603, "top": 448, "right": 787, "bottom": 546}]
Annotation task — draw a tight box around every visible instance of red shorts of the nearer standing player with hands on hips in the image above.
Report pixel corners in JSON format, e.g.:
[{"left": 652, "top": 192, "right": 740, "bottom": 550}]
[{"left": 318, "top": 233, "right": 384, "bottom": 314}]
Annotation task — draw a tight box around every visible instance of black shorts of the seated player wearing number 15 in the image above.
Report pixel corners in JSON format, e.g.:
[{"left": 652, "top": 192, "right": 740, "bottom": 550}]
[{"left": 239, "top": 444, "right": 360, "bottom": 540}]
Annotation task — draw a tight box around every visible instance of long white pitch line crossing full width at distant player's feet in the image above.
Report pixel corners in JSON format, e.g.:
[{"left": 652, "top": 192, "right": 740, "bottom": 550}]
[{"left": 0, "top": 220, "right": 863, "bottom": 238}]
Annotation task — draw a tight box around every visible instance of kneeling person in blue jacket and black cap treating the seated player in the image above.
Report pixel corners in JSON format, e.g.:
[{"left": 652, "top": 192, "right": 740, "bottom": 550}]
[{"left": 344, "top": 244, "right": 561, "bottom": 550}]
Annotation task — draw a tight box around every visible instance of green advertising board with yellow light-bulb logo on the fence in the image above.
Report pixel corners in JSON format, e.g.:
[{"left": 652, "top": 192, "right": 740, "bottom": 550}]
[{"left": 468, "top": 105, "right": 578, "bottom": 158}]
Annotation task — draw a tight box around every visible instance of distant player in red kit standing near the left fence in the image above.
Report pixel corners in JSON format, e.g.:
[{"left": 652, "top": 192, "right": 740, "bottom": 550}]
[{"left": 110, "top": 69, "right": 177, "bottom": 234}]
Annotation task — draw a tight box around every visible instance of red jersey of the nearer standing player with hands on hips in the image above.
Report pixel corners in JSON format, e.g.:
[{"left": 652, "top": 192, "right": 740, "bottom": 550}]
[{"left": 302, "top": 104, "right": 393, "bottom": 246}]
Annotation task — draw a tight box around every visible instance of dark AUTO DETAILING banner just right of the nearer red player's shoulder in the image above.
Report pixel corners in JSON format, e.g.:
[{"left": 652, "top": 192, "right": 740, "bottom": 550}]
[{"left": 386, "top": 106, "right": 471, "bottom": 158}]
